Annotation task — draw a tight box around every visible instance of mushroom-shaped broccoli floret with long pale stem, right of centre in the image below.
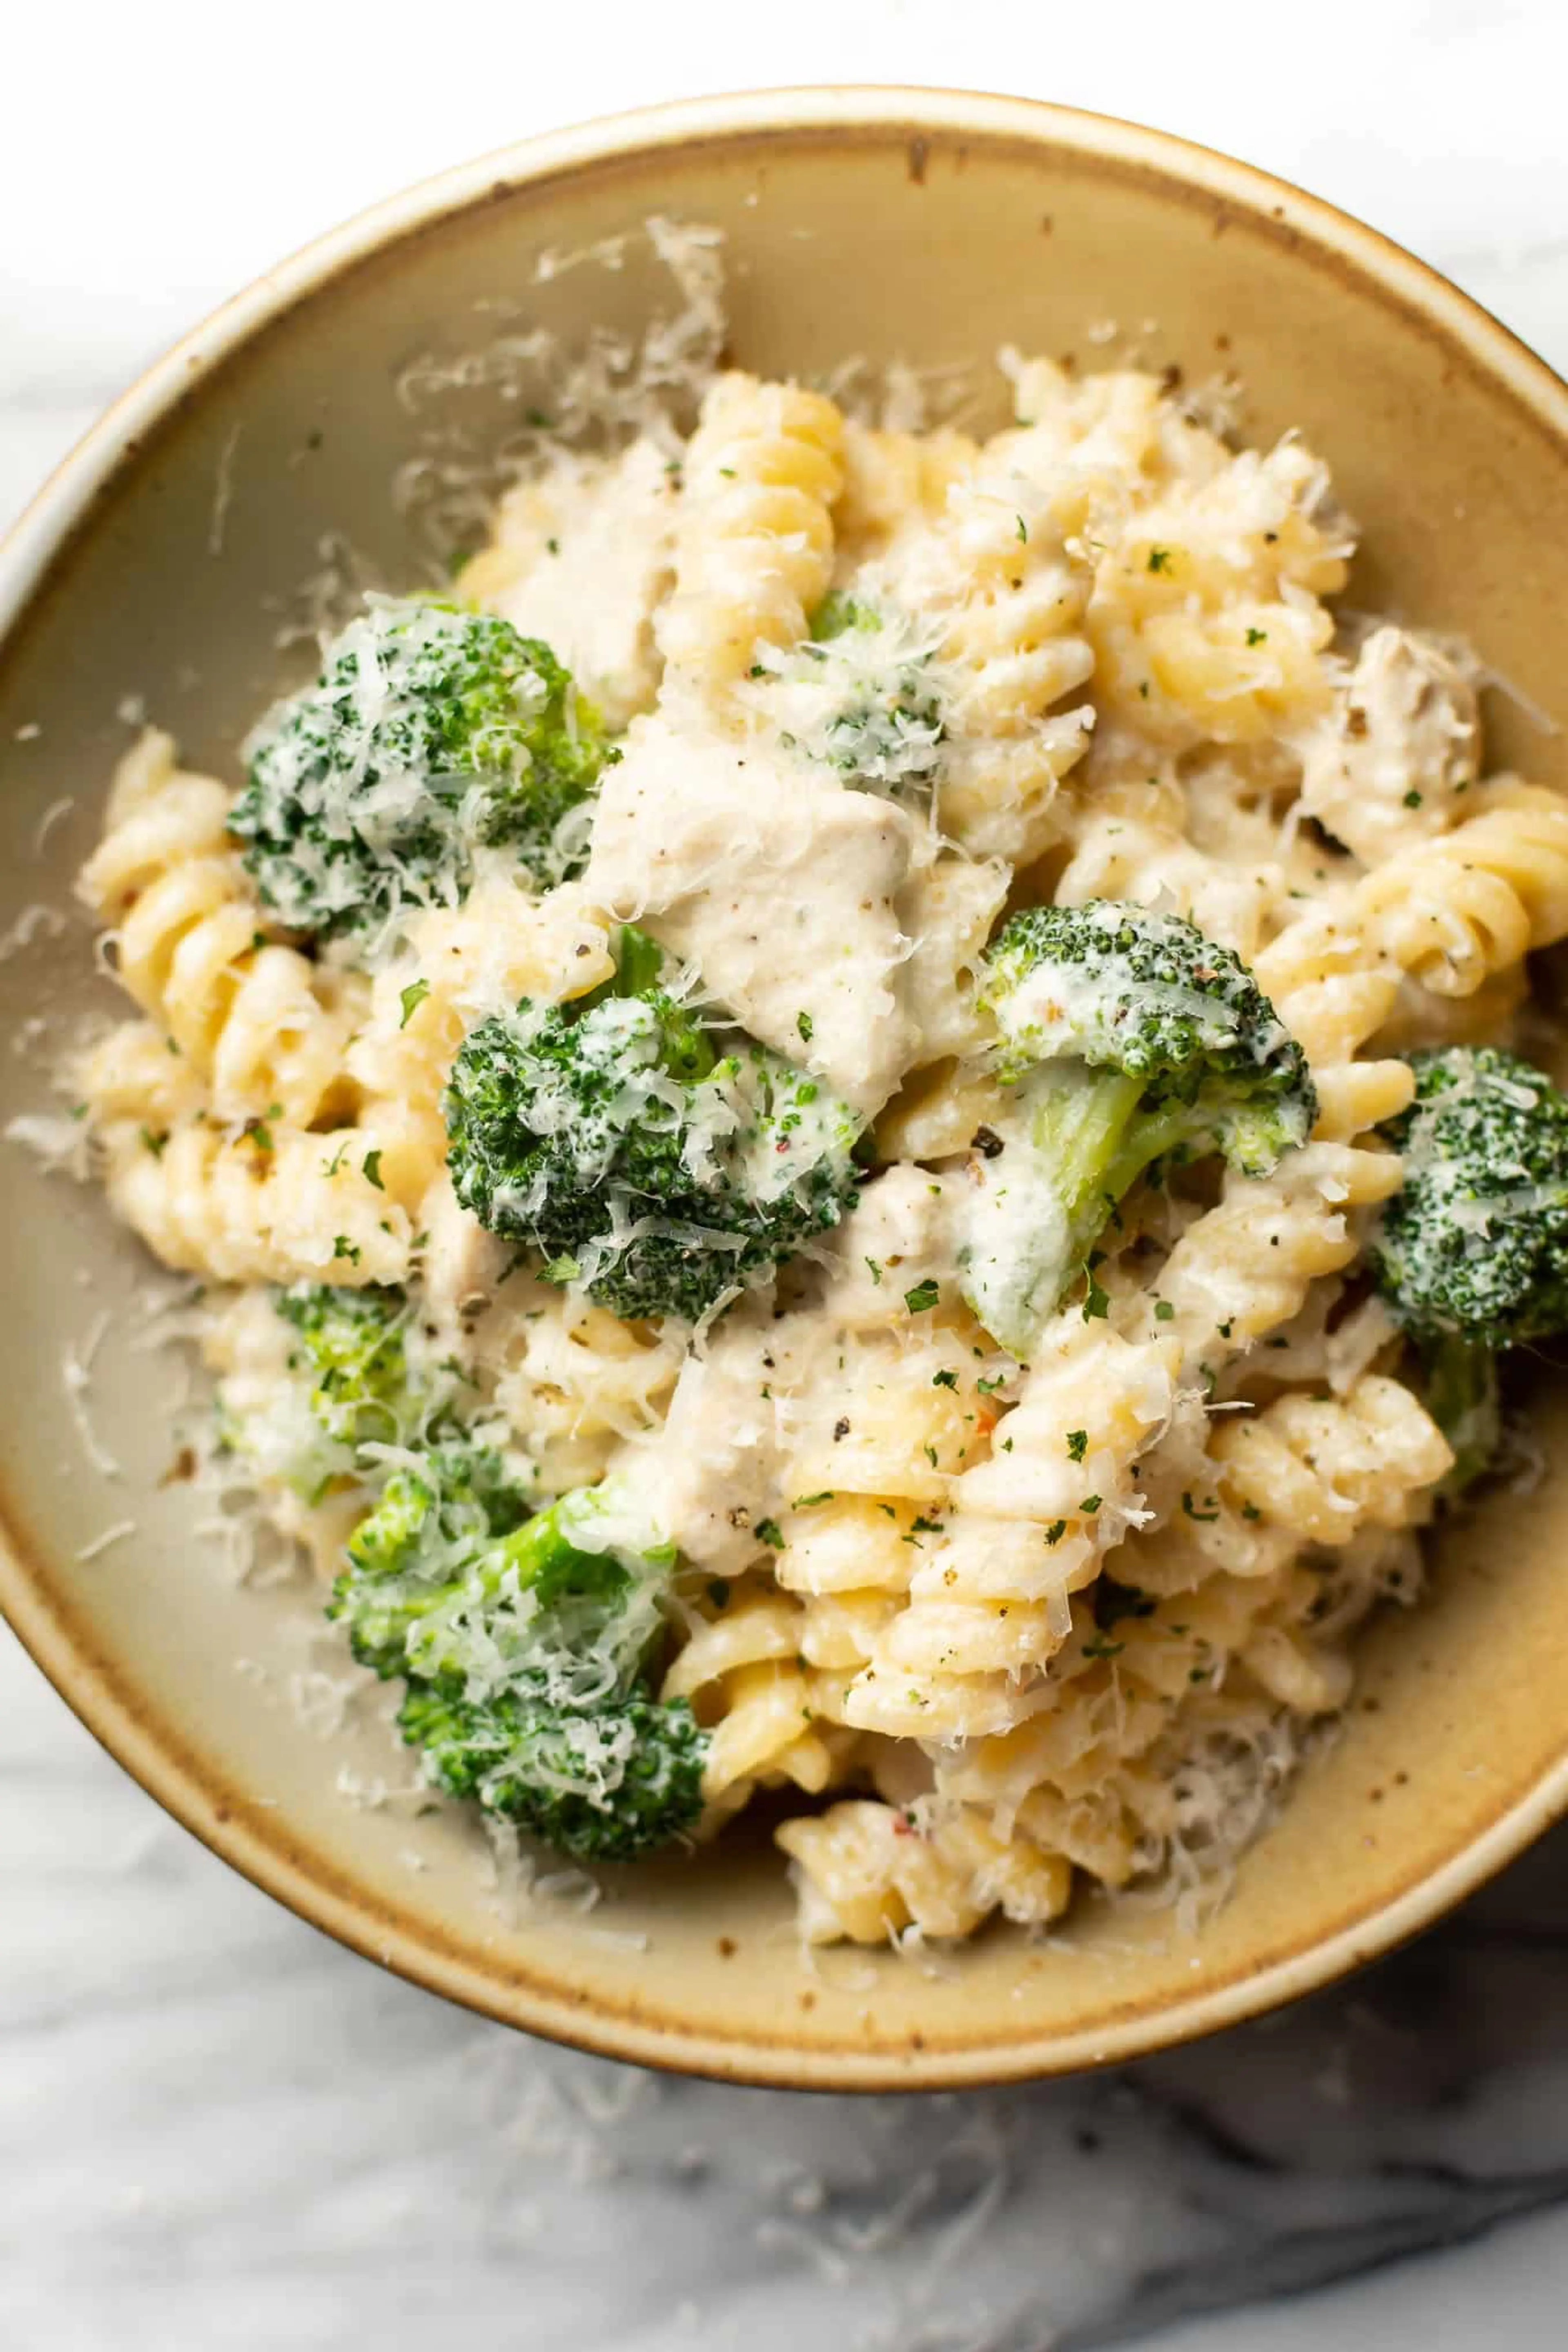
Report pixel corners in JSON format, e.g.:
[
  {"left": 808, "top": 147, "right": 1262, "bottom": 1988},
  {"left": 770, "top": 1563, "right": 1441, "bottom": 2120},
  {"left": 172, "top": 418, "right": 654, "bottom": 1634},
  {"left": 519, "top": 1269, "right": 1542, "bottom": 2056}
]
[{"left": 959, "top": 901, "right": 1316, "bottom": 1359}]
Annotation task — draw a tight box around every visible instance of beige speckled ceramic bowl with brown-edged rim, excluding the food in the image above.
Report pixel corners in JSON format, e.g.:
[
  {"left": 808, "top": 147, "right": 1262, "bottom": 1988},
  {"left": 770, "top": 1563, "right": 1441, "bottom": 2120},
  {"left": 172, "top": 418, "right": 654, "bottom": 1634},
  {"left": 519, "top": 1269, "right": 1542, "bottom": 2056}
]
[{"left": 0, "top": 89, "right": 1568, "bottom": 2089}]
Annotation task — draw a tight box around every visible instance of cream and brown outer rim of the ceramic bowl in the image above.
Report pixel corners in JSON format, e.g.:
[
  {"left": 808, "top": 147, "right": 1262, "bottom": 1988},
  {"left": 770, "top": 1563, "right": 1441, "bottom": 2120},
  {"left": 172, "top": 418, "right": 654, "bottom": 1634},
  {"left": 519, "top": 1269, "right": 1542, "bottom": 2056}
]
[{"left": 0, "top": 85, "right": 1568, "bottom": 2091}]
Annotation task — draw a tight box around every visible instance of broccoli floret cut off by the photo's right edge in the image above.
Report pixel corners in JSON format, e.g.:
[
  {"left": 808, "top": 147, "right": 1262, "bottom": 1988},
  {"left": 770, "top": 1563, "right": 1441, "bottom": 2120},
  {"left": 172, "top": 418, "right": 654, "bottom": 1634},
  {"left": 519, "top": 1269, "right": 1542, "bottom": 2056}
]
[{"left": 1368, "top": 1044, "right": 1568, "bottom": 1489}]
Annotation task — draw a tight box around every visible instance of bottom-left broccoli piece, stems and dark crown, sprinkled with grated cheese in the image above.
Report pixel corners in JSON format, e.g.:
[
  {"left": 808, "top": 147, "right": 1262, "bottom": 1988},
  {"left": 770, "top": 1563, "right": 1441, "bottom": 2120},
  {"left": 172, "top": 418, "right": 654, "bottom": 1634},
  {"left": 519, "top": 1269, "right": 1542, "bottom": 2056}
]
[{"left": 329, "top": 1451, "right": 708, "bottom": 1860}]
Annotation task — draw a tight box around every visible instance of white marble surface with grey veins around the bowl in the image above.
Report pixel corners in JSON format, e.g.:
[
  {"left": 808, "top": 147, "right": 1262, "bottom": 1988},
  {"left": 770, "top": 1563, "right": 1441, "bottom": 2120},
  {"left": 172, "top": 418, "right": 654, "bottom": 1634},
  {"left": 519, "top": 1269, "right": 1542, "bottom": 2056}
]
[{"left": 0, "top": 0, "right": 1568, "bottom": 2352}]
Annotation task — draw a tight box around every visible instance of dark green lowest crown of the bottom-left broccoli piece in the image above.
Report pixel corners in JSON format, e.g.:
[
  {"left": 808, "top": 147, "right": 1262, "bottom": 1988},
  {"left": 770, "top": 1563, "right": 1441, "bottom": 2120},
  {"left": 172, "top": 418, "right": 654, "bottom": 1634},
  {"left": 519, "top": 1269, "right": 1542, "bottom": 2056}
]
[{"left": 397, "top": 1684, "right": 708, "bottom": 1863}]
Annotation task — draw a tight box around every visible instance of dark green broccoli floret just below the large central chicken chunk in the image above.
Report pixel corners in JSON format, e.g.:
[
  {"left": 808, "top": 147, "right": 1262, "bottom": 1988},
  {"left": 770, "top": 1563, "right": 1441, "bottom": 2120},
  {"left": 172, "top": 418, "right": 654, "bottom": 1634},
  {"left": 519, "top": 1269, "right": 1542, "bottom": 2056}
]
[{"left": 444, "top": 929, "right": 858, "bottom": 1322}]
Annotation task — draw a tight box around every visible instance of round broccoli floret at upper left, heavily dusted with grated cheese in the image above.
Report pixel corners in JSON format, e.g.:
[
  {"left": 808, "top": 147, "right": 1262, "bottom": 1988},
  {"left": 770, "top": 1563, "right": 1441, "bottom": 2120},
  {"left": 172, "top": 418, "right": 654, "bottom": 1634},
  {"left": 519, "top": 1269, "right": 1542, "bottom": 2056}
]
[{"left": 230, "top": 597, "right": 616, "bottom": 941}]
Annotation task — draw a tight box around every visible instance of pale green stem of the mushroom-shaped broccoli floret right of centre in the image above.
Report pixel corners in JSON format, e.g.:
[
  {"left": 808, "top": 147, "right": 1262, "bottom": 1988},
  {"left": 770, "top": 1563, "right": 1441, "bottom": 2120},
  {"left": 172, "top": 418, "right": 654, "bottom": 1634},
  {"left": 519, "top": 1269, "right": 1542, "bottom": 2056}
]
[{"left": 964, "top": 1061, "right": 1192, "bottom": 1362}]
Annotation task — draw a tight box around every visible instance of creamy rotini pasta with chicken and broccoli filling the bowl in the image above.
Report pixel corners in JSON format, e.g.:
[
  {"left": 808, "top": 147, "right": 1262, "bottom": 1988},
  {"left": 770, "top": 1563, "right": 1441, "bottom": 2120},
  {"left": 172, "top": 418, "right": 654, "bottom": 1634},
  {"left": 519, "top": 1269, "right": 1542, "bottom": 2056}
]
[{"left": 78, "top": 332, "right": 1568, "bottom": 1943}]
